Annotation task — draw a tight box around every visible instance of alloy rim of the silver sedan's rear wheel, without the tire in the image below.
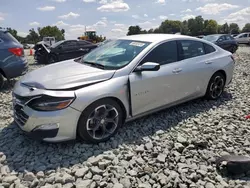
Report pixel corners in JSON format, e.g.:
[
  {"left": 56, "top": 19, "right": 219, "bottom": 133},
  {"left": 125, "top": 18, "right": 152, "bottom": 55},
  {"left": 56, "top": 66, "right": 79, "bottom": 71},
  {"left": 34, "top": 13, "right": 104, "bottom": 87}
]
[{"left": 209, "top": 76, "right": 224, "bottom": 99}]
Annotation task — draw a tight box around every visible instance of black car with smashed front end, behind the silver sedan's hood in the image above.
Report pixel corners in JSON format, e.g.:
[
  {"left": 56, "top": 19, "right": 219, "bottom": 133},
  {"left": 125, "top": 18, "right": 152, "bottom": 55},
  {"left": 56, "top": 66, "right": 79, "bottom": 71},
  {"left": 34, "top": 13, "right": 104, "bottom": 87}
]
[{"left": 35, "top": 40, "right": 97, "bottom": 64}]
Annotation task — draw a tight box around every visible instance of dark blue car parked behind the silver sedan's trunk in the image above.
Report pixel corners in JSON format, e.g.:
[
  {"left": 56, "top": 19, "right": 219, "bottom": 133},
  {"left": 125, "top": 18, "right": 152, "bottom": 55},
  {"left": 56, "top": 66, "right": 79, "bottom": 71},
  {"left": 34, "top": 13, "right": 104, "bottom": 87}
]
[{"left": 203, "top": 34, "right": 238, "bottom": 53}]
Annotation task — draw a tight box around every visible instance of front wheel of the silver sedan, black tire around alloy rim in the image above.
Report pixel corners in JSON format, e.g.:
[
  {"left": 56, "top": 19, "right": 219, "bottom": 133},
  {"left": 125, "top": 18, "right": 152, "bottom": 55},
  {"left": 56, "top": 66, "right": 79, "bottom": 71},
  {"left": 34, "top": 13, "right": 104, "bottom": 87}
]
[{"left": 77, "top": 99, "right": 124, "bottom": 144}]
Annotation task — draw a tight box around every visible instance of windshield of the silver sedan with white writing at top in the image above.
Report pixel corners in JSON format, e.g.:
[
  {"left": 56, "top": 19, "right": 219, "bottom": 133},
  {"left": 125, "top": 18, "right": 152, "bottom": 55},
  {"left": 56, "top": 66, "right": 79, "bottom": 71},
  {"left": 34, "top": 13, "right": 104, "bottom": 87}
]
[{"left": 82, "top": 40, "right": 150, "bottom": 69}]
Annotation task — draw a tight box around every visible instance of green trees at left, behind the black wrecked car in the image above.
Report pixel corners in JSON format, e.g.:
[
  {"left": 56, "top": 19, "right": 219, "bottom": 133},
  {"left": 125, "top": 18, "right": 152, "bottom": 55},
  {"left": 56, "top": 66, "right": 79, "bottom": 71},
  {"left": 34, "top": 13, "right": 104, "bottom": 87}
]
[{"left": 0, "top": 26, "right": 65, "bottom": 44}]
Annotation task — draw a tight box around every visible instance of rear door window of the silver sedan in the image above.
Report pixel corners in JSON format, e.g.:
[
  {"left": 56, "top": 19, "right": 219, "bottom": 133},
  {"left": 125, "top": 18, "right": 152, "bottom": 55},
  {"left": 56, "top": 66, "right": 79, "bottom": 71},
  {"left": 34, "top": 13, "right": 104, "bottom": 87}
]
[{"left": 178, "top": 40, "right": 206, "bottom": 60}]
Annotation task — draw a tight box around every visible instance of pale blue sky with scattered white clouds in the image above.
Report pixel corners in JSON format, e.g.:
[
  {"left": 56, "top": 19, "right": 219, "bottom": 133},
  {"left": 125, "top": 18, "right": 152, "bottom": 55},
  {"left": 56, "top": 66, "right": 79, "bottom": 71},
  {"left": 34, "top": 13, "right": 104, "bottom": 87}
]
[{"left": 0, "top": 0, "right": 250, "bottom": 39}]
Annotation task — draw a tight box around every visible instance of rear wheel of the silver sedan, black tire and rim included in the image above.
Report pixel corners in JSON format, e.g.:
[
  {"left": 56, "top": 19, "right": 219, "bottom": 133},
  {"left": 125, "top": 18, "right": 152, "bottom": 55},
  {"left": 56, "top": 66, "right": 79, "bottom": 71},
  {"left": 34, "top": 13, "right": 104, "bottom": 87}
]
[{"left": 205, "top": 72, "right": 226, "bottom": 100}]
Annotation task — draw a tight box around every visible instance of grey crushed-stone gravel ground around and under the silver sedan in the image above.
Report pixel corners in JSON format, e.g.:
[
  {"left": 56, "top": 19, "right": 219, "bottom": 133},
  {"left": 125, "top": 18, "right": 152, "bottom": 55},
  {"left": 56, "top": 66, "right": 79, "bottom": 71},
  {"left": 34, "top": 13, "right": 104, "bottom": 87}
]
[{"left": 0, "top": 47, "right": 250, "bottom": 188}]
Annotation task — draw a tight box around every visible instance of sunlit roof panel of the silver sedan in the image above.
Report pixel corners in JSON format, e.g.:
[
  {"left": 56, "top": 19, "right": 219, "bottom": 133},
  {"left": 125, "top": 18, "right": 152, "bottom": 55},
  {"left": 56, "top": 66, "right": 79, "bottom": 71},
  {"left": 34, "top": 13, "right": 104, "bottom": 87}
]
[{"left": 119, "top": 34, "right": 200, "bottom": 42}]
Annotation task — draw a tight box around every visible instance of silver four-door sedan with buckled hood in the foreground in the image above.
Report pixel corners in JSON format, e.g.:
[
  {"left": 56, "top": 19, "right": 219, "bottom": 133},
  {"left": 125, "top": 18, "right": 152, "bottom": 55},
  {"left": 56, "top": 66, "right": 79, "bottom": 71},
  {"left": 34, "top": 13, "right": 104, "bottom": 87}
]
[{"left": 13, "top": 34, "right": 235, "bottom": 143}]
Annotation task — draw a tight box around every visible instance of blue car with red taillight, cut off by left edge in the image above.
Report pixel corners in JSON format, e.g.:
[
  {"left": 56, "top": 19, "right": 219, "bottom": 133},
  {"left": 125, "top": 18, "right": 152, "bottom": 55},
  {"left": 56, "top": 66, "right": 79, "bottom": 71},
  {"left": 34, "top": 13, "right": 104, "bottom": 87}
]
[{"left": 0, "top": 30, "right": 28, "bottom": 89}]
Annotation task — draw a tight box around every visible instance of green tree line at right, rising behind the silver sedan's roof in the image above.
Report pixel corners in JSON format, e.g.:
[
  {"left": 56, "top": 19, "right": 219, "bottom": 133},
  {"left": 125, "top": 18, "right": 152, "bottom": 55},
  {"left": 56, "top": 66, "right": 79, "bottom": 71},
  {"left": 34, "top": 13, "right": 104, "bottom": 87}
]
[{"left": 127, "top": 16, "right": 250, "bottom": 36}]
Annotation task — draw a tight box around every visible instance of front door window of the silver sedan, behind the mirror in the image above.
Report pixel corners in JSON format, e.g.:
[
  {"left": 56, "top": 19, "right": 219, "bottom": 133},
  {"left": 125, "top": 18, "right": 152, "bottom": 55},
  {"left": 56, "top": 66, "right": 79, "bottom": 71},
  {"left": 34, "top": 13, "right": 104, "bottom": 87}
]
[{"left": 140, "top": 41, "right": 178, "bottom": 65}]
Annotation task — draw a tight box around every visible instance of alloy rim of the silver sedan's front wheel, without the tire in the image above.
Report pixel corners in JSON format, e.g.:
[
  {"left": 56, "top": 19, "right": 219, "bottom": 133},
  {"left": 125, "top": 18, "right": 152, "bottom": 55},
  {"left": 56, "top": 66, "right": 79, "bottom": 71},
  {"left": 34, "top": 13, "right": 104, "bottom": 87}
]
[{"left": 86, "top": 104, "right": 119, "bottom": 140}]
